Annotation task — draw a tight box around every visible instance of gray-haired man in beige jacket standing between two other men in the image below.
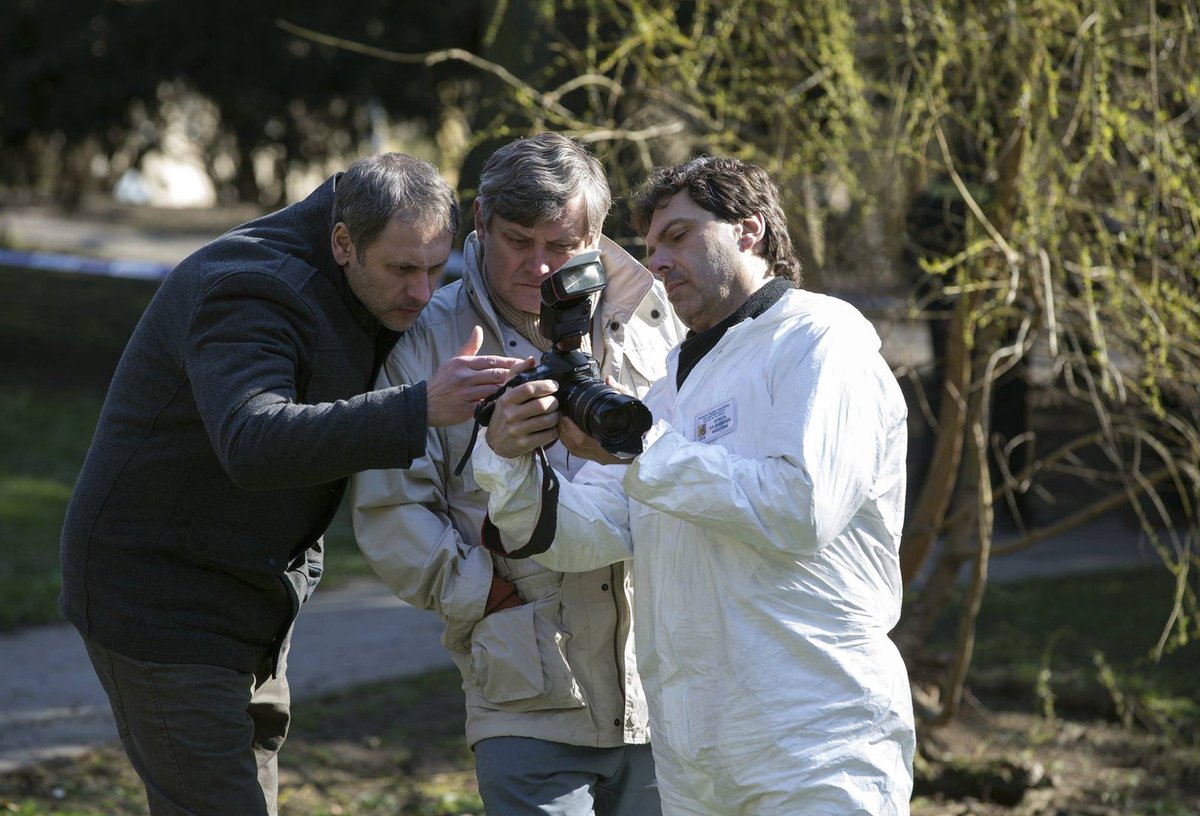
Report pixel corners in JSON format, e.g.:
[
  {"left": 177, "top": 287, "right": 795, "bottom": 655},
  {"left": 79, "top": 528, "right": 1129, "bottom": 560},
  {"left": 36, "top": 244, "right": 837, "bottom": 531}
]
[{"left": 353, "top": 133, "right": 683, "bottom": 816}]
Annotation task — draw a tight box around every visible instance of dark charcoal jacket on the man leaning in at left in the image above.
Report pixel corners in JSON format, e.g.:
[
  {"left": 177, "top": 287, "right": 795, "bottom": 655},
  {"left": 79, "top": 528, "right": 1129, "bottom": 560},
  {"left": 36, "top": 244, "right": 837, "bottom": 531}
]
[{"left": 61, "top": 176, "right": 426, "bottom": 672}]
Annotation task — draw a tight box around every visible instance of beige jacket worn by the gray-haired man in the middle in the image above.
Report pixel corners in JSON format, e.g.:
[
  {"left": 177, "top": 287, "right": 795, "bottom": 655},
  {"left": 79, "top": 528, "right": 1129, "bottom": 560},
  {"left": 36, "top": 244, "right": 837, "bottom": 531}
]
[{"left": 352, "top": 234, "right": 683, "bottom": 748}]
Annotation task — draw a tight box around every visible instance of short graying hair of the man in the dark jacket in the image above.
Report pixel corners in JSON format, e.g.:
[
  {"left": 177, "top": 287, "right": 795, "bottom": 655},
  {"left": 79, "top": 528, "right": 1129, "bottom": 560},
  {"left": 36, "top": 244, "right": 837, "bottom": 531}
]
[{"left": 334, "top": 152, "right": 458, "bottom": 257}]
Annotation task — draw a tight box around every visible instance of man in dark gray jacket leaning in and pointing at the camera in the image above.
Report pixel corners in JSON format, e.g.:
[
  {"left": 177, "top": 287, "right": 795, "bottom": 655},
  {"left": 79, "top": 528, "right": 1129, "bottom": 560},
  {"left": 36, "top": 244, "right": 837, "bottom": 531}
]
[{"left": 61, "top": 154, "right": 516, "bottom": 816}]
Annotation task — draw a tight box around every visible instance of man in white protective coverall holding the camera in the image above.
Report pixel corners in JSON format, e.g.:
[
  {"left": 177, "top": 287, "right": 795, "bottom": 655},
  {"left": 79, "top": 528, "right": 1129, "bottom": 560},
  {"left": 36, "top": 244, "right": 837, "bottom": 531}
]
[{"left": 473, "top": 157, "right": 914, "bottom": 816}]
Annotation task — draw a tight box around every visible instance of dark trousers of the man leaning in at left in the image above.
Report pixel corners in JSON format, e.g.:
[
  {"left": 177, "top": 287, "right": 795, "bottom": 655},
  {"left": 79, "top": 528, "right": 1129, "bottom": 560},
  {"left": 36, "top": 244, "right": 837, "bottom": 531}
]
[{"left": 84, "top": 637, "right": 290, "bottom": 816}]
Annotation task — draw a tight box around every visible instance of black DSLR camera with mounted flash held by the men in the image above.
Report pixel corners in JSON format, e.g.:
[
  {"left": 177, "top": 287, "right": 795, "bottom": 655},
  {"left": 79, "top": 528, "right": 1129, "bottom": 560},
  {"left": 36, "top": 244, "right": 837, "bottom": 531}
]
[{"left": 475, "top": 250, "right": 653, "bottom": 455}]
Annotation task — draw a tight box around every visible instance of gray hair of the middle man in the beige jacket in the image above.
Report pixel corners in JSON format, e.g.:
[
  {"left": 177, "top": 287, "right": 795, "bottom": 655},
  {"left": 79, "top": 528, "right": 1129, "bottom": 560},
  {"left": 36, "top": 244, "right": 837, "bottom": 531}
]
[{"left": 479, "top": 133, "right": 612, "bottom": 236}]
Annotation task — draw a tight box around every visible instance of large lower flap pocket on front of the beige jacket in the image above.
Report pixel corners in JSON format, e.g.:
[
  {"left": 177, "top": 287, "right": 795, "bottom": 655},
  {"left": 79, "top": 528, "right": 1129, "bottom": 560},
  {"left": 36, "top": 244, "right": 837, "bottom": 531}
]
[{"left": 468, "top": 598, "right": 586, "bottom": 712}]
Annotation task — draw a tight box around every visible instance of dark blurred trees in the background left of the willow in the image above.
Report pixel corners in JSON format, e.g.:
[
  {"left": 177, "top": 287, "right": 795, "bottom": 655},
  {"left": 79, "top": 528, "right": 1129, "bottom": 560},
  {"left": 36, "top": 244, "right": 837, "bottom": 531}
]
[{"left": 0, "top": 0, "right": 480, "bottom": 206}]
